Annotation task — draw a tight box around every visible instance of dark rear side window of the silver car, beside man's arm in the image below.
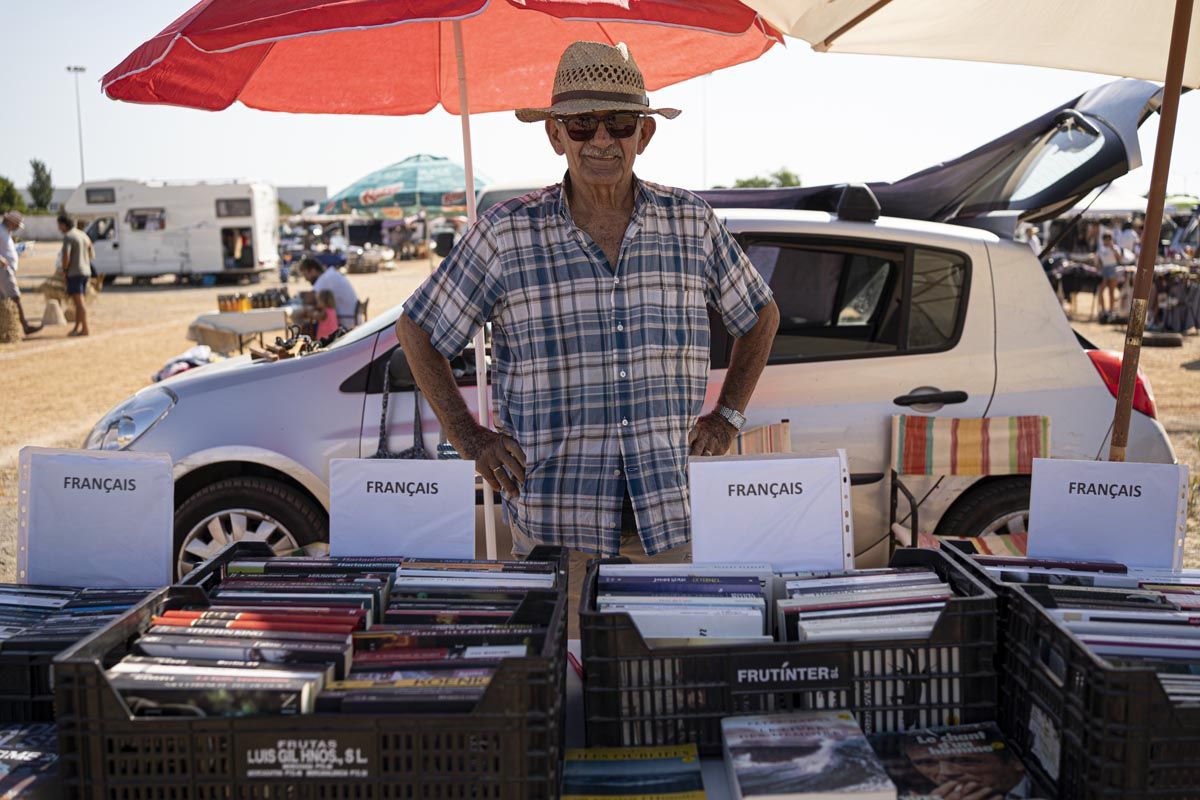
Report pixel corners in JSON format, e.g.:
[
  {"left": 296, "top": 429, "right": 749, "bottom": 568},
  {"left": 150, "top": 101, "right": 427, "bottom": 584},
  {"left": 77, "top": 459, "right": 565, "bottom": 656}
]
[{"left": 744, "top": 237, "right": 968, "bottom": 363}]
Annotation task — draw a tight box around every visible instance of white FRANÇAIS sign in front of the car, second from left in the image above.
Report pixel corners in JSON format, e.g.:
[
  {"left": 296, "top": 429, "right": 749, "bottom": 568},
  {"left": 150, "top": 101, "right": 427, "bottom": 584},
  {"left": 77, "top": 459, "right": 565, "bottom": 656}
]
[{"left": 329, "top": 458, "right": 475, "bottom": 559}]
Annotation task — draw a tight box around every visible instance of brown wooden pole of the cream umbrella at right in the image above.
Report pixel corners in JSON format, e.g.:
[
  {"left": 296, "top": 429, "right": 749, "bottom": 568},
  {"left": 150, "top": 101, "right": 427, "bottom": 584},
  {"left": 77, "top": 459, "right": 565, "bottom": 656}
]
[{"left": 1109, "top": 0, "right": 1193, "bottom": 461}]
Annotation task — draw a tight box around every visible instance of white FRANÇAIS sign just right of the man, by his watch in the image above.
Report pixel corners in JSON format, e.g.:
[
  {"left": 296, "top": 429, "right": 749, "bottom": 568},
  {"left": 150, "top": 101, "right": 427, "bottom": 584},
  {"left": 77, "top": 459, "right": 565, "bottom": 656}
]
[{"left": 688, "top": 450, "right": 854, "bottom": 570}]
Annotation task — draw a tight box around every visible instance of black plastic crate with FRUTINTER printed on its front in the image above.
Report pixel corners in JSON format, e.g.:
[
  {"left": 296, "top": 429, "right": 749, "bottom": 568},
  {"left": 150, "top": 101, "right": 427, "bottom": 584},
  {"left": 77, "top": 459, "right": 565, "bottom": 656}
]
[{"left": 580, "top": 548, "right": 996, "bottom": 756}]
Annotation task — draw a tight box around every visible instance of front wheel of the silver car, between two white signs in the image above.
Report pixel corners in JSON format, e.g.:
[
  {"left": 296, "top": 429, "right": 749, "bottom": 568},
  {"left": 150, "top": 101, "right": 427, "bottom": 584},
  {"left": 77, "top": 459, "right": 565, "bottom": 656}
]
[{"left": 175, "top": 476, "right": 329, "bottom": 577}]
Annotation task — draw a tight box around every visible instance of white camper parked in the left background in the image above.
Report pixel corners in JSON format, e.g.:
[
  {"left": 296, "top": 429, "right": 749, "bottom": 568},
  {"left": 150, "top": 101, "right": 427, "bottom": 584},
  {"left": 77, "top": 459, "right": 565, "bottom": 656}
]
[{"left": 66, "top": 180, "right": 280, "bottom": 279}]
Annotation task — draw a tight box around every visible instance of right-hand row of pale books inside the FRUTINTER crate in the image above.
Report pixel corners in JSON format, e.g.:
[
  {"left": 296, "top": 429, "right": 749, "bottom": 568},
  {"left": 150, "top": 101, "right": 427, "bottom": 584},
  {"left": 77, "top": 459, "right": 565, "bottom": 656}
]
[{"left": 775, "top": 567, "right": 954, "bottom": 642}]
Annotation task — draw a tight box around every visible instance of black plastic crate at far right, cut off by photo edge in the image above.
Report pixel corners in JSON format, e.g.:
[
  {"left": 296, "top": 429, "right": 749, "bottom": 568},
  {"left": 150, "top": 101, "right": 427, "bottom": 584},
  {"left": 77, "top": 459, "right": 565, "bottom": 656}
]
[{"left": 940, "top": 553, "right": 1200, "bottom": 800}]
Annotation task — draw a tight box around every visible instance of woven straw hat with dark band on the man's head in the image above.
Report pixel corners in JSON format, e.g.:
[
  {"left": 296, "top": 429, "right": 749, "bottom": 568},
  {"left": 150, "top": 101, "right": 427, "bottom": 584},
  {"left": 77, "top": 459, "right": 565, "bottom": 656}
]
[{"left": 517, "top": 42, "right": 679, "bottom": 122}]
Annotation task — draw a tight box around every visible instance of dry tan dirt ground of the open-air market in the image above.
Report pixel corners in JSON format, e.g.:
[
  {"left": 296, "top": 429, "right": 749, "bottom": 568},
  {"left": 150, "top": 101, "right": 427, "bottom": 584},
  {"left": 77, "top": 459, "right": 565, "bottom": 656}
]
[{"left": 0, "top": 243, "right": 1200, "bottom": 581}]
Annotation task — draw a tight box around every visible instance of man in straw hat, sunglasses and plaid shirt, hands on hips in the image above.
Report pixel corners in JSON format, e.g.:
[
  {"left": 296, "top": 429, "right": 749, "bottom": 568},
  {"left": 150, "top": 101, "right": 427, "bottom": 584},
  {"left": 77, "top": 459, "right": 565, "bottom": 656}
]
[{"left": 396, "top": 42, "right": 779, "bottom": 599}]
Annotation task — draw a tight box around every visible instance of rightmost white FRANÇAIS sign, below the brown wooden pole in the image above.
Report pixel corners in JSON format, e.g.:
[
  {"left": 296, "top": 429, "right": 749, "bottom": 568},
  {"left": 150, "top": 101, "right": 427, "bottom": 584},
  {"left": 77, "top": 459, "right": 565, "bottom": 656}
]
[{"left": 1028, "top": 458, "right": 1188, "bottom": 570}]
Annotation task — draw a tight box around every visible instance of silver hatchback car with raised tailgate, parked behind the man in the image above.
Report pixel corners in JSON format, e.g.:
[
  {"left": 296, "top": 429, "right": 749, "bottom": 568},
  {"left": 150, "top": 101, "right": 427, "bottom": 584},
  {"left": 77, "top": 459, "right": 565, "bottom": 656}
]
[{"left": 86, "top": 82, "right": 1175, "bottom": 572}]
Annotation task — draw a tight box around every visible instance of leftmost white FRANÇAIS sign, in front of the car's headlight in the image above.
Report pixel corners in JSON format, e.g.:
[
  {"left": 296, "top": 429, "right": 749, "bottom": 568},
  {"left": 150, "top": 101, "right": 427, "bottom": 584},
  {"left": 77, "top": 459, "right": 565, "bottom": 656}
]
[{"left": 17, "top": 447, "right": 175, "bottom": 589}]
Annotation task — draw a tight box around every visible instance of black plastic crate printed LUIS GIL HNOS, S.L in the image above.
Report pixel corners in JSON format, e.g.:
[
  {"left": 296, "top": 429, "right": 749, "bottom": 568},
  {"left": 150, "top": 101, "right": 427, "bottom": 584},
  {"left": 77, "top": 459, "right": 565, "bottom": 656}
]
[{"left": 54, "top": 546, "right": 568, "bottom": 800}]
